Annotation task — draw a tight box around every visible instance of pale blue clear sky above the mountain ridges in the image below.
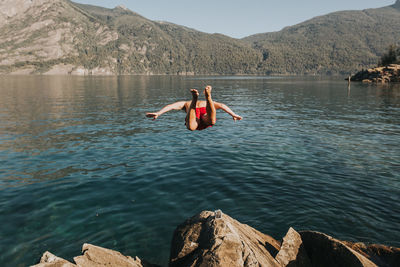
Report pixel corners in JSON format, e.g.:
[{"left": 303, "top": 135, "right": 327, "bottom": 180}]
[{"left": 74, "top": 0, "right": 396, "bottom": 38}]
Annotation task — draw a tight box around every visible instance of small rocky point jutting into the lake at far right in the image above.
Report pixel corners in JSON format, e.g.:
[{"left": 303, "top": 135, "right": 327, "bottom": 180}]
[{"left": 350, "top": 64, "right": 400, "bottom": 83}]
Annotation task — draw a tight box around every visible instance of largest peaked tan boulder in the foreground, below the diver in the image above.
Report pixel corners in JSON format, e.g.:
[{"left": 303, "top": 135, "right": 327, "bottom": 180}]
[{"left": 169, "top": 211, "right": 280, "bottom": 267}]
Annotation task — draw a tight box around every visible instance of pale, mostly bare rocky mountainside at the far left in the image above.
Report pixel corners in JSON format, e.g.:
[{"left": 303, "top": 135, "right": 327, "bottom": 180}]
[{"left": 0, "top": 0, "right": 118, "bottom": 73}]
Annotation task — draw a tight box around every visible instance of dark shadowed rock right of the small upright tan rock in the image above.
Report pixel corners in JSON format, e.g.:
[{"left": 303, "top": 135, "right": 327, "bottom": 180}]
[{"left": 300, "top": 231, "right": 377, "bottom": 267}]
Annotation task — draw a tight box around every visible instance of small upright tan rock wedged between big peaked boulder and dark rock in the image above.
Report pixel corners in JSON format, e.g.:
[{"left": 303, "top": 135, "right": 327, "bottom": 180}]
[{"left": 275, "top": 227, "right": 311, "bottom": 267}]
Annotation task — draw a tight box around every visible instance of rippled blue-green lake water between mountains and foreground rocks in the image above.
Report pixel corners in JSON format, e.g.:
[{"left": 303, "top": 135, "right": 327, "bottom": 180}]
[{"left": 0, "top": 76, "right": 400, "bottom": 266}]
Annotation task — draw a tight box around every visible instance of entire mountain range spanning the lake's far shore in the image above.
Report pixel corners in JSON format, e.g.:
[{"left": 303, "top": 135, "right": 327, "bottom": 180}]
[{"left": 0, "top": 0, "right": 400, "bottom": 74}]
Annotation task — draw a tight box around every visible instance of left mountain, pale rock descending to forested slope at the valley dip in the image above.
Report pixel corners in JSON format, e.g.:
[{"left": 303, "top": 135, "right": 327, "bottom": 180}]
[{"left": 0, "top": 0, "right": 260, "bottom": 74}]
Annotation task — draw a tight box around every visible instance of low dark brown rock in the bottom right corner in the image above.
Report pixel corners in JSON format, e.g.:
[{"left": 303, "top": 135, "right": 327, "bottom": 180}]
[{"left": 343, "top": 241, "right": 400, "bottom": 267}]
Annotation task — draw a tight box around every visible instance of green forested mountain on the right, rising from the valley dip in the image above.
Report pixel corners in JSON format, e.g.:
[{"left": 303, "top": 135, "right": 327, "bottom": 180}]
[{"left": 243, "top": 0, "right": 400, "bottom": 74}]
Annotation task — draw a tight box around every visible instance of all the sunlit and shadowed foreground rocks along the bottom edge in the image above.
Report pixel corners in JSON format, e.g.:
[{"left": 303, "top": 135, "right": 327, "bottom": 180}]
[{"left": 34, "top": 211, "right": 400, "bottom": 267}]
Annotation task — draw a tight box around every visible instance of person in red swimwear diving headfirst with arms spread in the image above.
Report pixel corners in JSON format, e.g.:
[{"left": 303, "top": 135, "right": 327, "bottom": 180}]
[{"left": 146, "top": 86, "right": 242, "bottom": 131}]
